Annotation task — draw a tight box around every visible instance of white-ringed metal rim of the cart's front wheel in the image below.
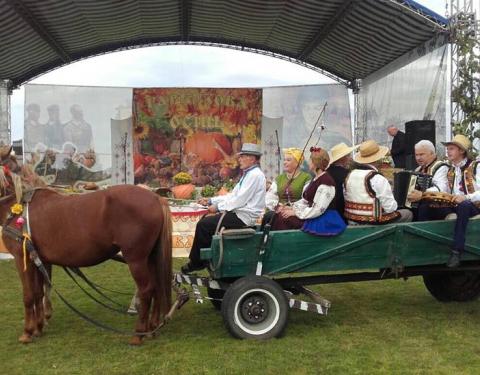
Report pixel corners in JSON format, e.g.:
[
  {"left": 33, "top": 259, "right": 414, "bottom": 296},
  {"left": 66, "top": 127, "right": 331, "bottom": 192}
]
[{"left": 234, "top": 289, "right": 280, "bottom": 336}]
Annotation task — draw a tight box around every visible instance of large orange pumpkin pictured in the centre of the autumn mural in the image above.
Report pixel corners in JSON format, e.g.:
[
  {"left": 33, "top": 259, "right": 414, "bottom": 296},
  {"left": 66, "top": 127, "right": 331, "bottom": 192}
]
[{"left": 185, "top": 132, "right": 232, "bottom": 164}]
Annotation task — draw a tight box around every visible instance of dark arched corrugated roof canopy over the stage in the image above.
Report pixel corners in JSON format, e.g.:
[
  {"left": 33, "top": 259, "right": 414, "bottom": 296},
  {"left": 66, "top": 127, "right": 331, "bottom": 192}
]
[{"left": 0, "top": 0, "right": 448, "bottom": 89}]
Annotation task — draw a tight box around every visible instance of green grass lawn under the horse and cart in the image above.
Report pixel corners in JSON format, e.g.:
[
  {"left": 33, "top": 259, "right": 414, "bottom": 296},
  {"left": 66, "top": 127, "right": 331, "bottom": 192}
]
[{"left": 0, "top": 259, "right": 480, "bottom": 375}]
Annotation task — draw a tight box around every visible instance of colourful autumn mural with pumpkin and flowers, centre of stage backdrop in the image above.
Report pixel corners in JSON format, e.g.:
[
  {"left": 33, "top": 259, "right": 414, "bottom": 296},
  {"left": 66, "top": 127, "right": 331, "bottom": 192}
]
[{"left": 133, "top": 88, "right": 262, "bottom": 187}]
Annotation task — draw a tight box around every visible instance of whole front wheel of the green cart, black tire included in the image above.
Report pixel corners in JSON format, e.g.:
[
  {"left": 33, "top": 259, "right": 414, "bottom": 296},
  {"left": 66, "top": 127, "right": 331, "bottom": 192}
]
[{"left": 222, "top": 276, "right": 289, "bottom": 340}]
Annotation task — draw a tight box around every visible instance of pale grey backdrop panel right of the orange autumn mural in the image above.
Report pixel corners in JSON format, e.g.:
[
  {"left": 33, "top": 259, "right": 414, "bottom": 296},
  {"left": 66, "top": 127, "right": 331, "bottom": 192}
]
[{"left": 262, "top": 84, "right": 352, "bottom": 179}]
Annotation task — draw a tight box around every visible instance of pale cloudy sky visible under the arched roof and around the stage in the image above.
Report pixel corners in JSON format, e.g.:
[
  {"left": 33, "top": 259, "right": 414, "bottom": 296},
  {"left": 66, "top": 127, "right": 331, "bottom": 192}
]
[{"left": 11, "top": 0, "right": 445, "bottom": 140}]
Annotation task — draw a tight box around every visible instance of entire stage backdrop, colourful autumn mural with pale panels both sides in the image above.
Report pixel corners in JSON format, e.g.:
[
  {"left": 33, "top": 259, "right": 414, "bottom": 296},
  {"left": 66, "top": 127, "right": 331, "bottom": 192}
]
[{"left": 24, "top": 84, "right": 351, "bottom": 186}]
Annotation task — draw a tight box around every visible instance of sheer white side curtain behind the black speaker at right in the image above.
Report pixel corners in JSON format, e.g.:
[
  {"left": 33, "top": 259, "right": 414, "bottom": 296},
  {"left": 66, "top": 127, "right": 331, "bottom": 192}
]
[{"left": 357, "top": 36, "right": 450, "bottom": 151}]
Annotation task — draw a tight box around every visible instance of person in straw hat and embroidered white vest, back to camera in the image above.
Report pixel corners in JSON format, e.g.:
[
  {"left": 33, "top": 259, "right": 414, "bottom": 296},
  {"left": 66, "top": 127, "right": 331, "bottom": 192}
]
[{"left": 344, "top": 140, "right": 413, "bottom": 225}]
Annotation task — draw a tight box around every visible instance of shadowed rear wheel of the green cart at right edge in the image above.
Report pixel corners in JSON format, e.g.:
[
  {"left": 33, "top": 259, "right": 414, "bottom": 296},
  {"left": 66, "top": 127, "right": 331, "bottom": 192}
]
[{"left": 423, "top": 271, "right": 480, "bottom": 302}]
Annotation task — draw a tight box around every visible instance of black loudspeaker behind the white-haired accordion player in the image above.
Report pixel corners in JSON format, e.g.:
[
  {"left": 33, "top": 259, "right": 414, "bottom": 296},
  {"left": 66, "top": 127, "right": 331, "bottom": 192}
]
[{"left": 405, "top": 120, "right": 436, "bottom": 170}]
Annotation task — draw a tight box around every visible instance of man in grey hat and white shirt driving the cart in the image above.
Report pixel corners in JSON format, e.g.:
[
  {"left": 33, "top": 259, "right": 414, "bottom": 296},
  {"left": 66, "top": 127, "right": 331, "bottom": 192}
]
[{"left": 181, "top": 143, "right": 266, "bottom": 273}]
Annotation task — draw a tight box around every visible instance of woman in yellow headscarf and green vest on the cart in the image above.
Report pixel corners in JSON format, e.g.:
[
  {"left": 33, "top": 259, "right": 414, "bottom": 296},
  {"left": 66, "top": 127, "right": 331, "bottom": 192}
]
[{"left": 262, "top": 147, "right": 312, "bottom": 228}]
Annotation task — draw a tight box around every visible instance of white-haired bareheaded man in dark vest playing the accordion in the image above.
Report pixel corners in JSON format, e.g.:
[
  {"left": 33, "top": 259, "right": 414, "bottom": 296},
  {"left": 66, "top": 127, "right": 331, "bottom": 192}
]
[{"left": 407, "top": 139, "right": 450, "bottom": 221}]
